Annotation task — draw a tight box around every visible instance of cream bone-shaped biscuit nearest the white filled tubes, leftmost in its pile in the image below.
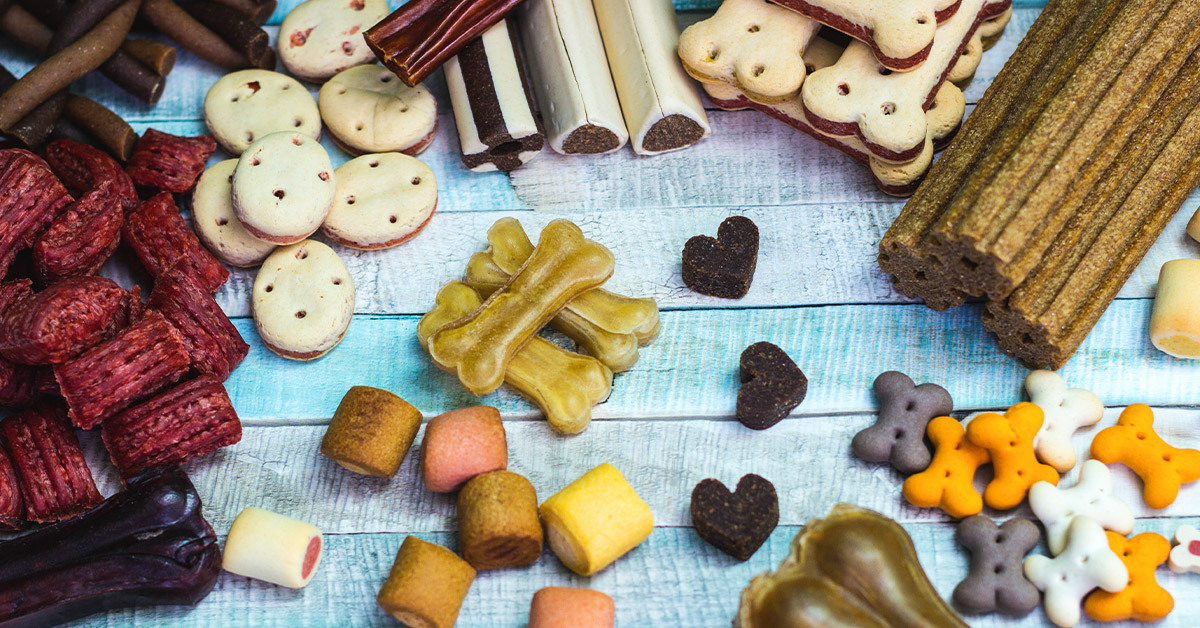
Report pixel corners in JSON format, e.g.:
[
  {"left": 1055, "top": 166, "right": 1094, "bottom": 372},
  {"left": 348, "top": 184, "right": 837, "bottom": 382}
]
[{"left": 679, "top": 0, "right": 821, "bottom": 104}]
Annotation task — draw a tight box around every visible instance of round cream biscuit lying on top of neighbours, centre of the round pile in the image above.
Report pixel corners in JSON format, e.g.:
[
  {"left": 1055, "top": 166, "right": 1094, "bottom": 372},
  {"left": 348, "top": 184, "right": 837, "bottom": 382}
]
[{"left": 233, "top": 133, "right": 337, "bottom": 244}]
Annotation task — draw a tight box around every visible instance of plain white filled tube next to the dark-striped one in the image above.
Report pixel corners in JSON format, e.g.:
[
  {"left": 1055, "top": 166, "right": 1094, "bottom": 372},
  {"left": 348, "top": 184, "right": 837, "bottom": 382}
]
[{"left": 517, "top": 0, "right": 629, "bottom": 155}]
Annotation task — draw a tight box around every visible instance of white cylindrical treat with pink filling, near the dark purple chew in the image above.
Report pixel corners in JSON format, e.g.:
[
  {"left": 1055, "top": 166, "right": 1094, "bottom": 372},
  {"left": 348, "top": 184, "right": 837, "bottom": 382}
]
[{"left": 221, "top": 508, "right": 324, "bottom": 588}]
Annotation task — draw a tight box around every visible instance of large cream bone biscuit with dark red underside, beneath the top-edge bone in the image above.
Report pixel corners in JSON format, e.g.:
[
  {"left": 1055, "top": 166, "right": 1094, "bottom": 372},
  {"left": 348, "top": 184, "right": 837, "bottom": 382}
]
[{"left": 800, "top": 0, "right": 1012, "bottom": 162}]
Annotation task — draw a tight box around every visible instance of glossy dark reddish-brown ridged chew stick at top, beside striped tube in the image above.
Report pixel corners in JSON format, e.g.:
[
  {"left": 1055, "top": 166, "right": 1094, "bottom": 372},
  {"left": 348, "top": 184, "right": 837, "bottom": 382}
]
[{"left": 364, "top": 0, "right": 521, "bottom": 86}]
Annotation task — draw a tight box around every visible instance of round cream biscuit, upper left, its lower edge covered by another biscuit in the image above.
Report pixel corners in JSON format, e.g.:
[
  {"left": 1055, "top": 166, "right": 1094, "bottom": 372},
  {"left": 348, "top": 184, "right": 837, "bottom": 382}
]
[{"left": 204, "top": 70, "right": 320, "bottom": 156}]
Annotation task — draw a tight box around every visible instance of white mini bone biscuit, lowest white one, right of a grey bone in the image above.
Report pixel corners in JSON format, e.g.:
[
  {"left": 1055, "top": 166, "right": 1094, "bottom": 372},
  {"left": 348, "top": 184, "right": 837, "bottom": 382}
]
[{"left": 1025, "top": 516, "right": 1129, "bottom": 628}]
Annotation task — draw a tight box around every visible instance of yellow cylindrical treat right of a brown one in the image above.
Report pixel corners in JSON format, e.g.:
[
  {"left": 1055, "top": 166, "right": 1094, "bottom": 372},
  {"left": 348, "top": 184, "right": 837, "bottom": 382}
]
[{"left": 539, "top": 462, "right": 654, "bottom": 575}]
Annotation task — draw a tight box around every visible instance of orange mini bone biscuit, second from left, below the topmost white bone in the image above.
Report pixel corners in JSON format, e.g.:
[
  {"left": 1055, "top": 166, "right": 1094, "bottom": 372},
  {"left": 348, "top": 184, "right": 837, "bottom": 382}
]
[{"left": 967, "top": 403, "right": 1058, "bottom": 510}]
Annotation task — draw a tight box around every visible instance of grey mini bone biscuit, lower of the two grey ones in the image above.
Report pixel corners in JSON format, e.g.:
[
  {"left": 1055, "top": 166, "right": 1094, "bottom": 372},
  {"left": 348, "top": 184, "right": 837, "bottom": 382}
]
[{"left": 954, "top": 515, "right": 1042, "bottom": 617}]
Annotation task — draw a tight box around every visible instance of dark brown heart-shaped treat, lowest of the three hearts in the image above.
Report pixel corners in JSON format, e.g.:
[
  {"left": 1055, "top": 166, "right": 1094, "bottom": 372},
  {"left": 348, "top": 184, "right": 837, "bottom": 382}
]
[{"left": 691, "top": 473, "right": 779, "bottom": 561}]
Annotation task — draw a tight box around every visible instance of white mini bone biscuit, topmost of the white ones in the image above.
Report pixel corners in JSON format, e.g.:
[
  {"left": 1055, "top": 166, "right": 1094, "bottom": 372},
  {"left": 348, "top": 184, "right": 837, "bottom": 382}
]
[{"left": 1025, "top": 371, "right": 1104, "bottom": 473}]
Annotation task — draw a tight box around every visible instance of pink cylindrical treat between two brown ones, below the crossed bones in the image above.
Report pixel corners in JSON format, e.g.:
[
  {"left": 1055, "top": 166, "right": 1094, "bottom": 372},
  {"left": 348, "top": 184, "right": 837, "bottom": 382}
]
[{"left": 421, "top": 406, "right": 509, "bottom": 492}]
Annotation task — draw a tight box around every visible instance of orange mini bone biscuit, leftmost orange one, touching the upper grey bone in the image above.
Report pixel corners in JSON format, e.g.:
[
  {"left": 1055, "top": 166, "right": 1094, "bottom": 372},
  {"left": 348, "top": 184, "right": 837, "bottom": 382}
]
[{"left": 904, "top": 417, "right": 991, "bottom": 519}]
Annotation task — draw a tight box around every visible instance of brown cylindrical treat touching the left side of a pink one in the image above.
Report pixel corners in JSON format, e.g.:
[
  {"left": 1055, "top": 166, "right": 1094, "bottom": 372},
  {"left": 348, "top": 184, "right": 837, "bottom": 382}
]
[{"left": 320, "top": 385, "right": 421, "bottom": 478}]
